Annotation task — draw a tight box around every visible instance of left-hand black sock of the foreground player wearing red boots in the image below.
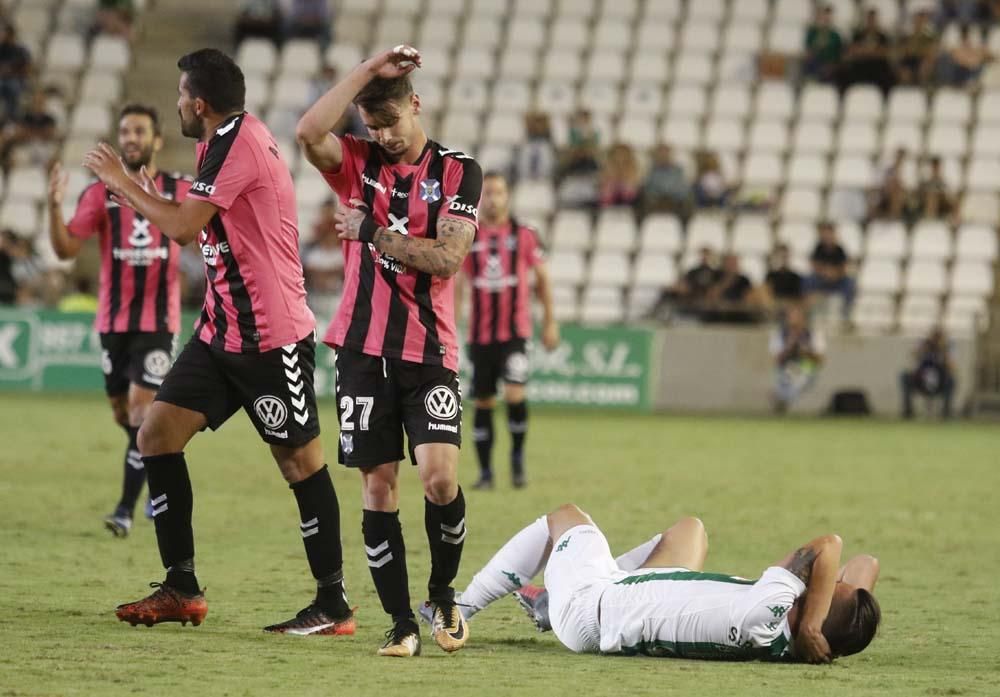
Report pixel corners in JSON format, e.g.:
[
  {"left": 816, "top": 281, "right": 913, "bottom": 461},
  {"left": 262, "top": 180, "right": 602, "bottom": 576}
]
[{"left": 142, "top": 453, "right": 201, "bottom": 595}]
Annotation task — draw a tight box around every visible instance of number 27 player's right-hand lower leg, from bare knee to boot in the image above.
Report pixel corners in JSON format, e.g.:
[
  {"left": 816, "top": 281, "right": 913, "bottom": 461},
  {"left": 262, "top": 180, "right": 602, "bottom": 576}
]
[{"left": 413, "top": 443, "right": 469, "bottom": 652}]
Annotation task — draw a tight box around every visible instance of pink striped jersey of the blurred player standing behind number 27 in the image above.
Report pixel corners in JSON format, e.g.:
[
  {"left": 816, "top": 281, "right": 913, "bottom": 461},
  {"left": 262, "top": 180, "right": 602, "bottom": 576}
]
[{"left": 463, "top": 219, "right": 545, "bottom": 344}]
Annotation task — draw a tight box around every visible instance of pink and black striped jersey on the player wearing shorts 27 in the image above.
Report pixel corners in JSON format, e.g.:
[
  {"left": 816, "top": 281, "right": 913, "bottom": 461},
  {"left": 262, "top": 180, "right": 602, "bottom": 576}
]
[{"left": 323, "top": 136, "right": 483, "bottom": 370}]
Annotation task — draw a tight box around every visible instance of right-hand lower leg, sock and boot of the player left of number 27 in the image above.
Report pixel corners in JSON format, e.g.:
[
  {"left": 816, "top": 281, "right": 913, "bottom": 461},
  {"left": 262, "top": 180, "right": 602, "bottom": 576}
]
[{"left": 264, "top": 437, "right": 355, "bottom": 636}]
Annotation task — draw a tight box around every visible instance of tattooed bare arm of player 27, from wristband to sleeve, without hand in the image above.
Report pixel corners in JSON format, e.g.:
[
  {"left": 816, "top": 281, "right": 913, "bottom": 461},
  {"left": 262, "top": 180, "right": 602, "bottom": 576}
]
[{"left": 374, "top": 218, "right": 476, "bottom": 276}]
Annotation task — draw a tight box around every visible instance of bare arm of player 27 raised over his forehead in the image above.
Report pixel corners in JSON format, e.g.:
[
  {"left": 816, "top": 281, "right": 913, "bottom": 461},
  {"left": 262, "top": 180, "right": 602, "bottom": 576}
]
[{"left": 295, "top": 45, "right": 420, "bottom": 172}]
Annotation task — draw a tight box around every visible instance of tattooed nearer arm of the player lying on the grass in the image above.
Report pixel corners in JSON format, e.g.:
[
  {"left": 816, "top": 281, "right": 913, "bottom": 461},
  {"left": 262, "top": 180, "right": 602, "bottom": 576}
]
[{"left": 779, "top": 535, "right": 844, "bottom": 663}]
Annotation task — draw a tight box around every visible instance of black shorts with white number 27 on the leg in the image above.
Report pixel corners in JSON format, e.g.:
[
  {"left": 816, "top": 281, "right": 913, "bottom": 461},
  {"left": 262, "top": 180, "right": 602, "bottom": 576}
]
[{"left": 337, "top": 348, "right": 462, "bottom": 467}]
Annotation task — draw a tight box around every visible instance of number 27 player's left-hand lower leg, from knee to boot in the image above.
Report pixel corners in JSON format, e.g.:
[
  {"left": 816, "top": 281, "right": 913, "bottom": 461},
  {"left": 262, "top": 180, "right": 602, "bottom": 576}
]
[{"left": 360, "top": 462, "right": 420, "bottom": 657}]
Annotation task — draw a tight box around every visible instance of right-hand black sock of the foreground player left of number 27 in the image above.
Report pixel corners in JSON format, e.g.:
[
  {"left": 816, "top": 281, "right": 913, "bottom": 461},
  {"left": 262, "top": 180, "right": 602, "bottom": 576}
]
[{"left": 291, "top": 465, "right": 350, "bottom": 617}]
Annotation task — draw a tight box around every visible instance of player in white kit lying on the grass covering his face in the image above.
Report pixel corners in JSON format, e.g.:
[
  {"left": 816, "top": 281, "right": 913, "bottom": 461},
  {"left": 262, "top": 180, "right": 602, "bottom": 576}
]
[{"left": 442, "top": 504, "right": 881, "bottom": 663}]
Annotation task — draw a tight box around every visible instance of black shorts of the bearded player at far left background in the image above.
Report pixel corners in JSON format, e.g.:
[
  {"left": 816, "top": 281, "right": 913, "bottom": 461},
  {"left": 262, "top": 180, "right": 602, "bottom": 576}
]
[{"left": 101, "top": 332, "right": 174, "bottom": 397}]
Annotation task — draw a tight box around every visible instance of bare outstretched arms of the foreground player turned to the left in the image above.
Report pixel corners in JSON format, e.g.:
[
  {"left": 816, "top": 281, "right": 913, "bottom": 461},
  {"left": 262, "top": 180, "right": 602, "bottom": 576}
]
[{"left": 83, "top": 143, "right": 213, "bottom": 245}]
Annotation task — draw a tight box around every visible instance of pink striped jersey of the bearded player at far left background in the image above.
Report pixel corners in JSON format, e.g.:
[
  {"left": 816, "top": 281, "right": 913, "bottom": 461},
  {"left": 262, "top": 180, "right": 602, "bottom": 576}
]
[{"left": 66, "top": 172, "right": 191, "bottom": 334}]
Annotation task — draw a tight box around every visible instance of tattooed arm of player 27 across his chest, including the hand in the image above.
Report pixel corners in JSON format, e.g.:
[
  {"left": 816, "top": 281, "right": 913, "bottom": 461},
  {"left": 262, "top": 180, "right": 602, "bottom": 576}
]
[{"left": 335, "top": 199, "right": 476, "bottom": 278}]
